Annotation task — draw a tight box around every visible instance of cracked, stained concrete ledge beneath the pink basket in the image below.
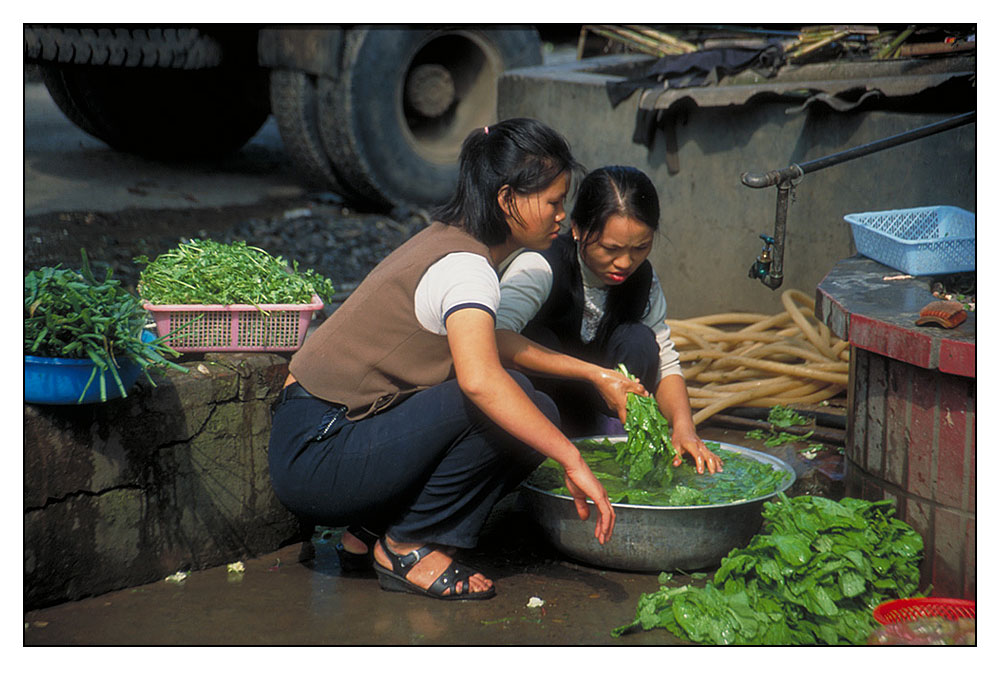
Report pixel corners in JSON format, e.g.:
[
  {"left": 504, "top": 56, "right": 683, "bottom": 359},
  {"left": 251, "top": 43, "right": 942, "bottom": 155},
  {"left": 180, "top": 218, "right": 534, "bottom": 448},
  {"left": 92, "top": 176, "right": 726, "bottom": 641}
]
[{"left": 24, "top": 354, "right": 299, "bottom": 609}]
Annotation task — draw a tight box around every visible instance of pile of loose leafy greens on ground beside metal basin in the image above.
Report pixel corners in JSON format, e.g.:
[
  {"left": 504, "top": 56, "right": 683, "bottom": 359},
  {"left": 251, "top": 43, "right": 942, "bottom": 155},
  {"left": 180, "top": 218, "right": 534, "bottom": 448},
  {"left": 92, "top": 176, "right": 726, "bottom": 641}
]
[{"left": 612, "top": 494, "right": 923, "bottom": 645}]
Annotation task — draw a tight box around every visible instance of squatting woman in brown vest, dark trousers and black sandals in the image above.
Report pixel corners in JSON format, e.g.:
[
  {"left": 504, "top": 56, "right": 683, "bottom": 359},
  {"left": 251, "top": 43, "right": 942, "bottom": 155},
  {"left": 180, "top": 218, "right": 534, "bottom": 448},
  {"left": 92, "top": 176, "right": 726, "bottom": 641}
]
[{"left": 269, "top": 119, "right": 647, "bottom": 600}]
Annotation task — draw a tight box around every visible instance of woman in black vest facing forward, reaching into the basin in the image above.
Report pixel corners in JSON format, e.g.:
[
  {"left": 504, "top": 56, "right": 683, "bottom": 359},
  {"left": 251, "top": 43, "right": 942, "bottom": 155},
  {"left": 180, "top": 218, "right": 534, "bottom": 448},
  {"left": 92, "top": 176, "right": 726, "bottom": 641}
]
[{"left": 497, "top": 166, "right": 722, "bottom": 473}]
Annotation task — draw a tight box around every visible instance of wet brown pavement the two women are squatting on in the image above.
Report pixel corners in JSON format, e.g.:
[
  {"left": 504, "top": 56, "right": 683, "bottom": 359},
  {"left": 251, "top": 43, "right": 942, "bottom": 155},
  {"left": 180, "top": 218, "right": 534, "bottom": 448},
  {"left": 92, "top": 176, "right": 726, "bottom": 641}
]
[{"left": 23, "top": 428, "right": 844, "bottom": 646}]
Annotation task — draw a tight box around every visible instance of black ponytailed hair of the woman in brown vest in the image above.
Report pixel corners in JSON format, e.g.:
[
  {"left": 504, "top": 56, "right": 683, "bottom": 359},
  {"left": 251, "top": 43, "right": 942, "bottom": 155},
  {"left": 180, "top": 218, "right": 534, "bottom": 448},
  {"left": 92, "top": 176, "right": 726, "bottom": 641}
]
[{"left": 433, "top": 118, "right": 582, "bottom": 245}]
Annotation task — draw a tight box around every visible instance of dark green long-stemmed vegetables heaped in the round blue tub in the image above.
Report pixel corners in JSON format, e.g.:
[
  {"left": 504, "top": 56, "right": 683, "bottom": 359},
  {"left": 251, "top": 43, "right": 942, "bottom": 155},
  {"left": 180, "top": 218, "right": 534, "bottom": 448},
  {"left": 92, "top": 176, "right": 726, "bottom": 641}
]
[{"left": 24, "top": 250, "right": 187, "bottom": 401}]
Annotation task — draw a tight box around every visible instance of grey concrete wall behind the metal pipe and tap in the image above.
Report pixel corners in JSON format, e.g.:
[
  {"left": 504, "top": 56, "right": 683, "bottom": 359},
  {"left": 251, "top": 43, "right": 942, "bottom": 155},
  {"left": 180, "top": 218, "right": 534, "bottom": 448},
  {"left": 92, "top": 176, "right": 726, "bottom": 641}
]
[{"left": 498, "top": 57, "right": 976, "bottom": 318}]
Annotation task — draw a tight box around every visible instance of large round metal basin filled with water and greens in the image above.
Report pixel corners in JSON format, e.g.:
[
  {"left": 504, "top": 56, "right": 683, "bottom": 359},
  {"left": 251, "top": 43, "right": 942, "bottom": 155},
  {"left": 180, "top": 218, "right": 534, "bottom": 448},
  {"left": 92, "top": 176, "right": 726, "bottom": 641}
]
[{"left": 521, "top": 435, "right": 795, "bottom": 572}]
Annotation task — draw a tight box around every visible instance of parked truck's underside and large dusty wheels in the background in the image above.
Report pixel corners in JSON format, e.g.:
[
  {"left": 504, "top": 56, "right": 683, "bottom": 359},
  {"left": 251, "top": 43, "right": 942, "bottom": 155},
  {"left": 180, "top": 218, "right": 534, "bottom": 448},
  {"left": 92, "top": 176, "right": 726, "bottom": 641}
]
[{"left": 24, "top": 24, "right": 542, "bottom": 209}]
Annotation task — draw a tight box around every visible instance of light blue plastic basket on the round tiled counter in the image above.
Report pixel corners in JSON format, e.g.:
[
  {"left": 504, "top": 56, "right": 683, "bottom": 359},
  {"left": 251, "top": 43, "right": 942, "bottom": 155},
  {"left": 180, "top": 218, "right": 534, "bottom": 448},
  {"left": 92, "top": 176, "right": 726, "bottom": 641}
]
[{"left": 844, "top": 206, "right": 976, "bottom": 276}]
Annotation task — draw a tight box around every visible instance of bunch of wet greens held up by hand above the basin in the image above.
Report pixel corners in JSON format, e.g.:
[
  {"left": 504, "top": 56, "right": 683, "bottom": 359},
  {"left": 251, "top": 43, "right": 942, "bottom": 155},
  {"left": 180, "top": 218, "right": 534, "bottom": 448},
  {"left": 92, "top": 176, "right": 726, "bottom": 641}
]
[{"left": 615, "top": 364, "right": 678, "bottom": 489}]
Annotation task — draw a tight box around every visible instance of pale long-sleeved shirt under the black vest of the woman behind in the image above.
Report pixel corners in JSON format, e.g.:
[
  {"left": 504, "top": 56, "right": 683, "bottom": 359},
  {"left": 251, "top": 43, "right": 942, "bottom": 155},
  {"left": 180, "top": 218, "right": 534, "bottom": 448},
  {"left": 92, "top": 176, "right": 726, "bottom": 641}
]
[{"left": 496, "top": 251, "right": 684, "bottom": 392}]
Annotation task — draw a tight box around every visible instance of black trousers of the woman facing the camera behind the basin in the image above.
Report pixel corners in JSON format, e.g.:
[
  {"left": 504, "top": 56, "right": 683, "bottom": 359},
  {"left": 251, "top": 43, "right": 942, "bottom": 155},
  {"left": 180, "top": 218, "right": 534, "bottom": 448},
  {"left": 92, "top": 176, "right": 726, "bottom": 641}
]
[{"left": 521, "top": 322, "right": 660, "bottom": 437}]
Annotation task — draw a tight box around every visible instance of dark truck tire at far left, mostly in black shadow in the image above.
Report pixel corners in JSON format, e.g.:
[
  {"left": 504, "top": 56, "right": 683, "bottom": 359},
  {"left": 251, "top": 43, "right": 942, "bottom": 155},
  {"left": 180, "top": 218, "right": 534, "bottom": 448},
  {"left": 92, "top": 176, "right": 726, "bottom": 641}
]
[{"left": 24, "top": 26, "right": 270, "bottom": 160}]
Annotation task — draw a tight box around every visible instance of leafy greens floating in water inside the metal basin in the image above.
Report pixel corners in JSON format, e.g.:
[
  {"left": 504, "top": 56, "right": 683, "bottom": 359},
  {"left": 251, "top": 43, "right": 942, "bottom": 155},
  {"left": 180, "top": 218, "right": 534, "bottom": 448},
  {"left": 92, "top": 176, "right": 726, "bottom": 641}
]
[{"left": 528, "top": 439, "right": 789, "bottom": 507}]
